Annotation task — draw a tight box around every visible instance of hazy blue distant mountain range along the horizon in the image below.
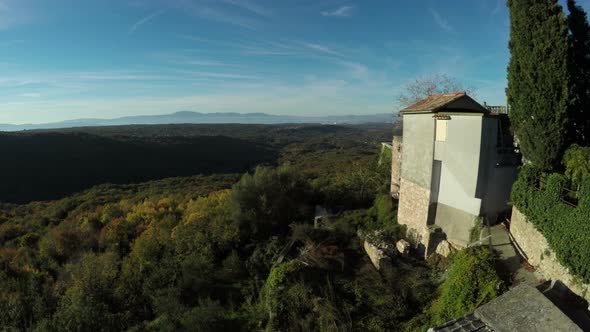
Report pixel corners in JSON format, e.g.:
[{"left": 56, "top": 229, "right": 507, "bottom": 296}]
[{"left": 0, "top": 111, "right": 394, "bottom": 131}]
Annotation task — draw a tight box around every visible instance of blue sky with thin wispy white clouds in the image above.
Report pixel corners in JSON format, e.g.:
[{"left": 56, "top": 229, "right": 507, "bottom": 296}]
[{"left": 0, "top": 0, "right": 556, "bottom": 123}]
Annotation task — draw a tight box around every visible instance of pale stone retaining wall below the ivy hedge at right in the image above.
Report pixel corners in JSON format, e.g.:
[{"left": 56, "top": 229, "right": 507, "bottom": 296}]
[{"left": 510, "top": 207, "right": 590, "bottom": 300}]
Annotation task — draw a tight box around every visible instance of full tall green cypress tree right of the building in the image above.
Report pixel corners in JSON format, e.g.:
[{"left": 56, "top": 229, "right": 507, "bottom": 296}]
[{"left": 508, "top": 0, "right": 574, "bottom": 170}]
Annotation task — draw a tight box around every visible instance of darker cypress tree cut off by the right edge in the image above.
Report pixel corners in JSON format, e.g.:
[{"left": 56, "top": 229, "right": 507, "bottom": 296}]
[{"left": 567, "top": 0, "right": 590, "bottom": 146}]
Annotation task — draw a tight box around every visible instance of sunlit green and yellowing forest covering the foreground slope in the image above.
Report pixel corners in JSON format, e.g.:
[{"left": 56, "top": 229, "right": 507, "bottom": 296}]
[{"left": 0, "top": 123, "right": 500, "bottom": 331}]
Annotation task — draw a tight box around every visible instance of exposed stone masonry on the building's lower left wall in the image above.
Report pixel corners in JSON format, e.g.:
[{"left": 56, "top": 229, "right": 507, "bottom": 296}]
[{"left": 397, "top": 178, "right": 430, "bottom": 244}]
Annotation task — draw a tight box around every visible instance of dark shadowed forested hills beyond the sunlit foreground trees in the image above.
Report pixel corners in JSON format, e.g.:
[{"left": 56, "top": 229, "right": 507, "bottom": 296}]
[{"left": 0, "top": 125, "right": 398, "bottom": 203}]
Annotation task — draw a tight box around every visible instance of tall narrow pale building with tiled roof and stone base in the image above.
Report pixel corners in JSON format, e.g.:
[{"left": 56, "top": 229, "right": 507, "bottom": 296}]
[{"left": 391, "top": 92, "right": 520, "bottom": 255}]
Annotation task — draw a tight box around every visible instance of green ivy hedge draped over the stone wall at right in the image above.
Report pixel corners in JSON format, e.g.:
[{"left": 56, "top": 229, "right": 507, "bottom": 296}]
[{"left": 512, "top": 166, "right": 590, "bottom": 283}]
